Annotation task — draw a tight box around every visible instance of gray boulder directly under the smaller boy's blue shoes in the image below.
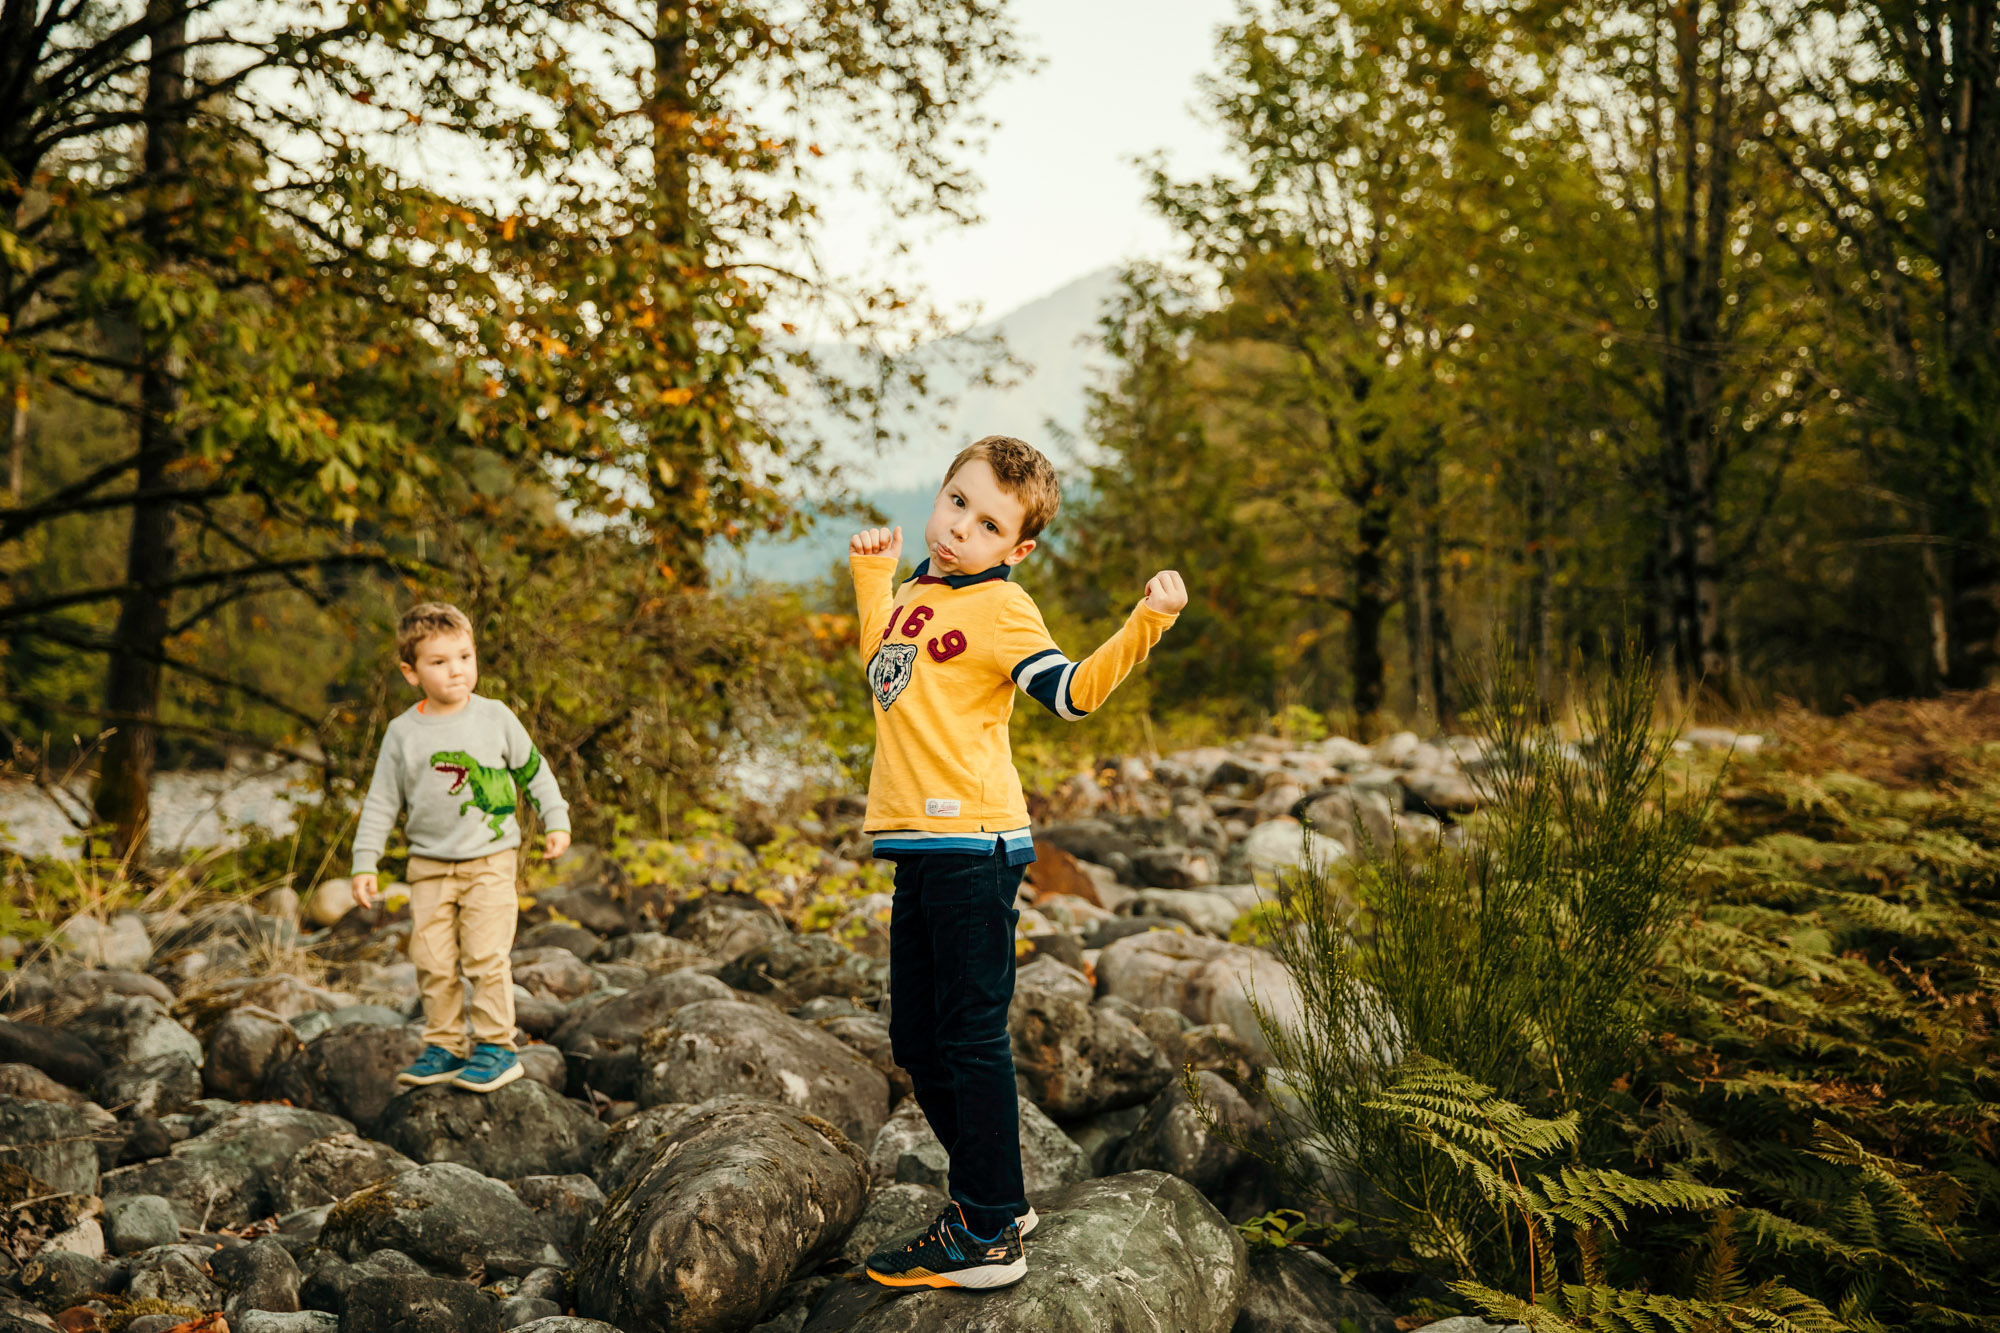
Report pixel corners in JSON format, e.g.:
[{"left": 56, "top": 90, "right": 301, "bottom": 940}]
[{"left": 374, "top": 1079, "right": 604, "bottom": 1179}]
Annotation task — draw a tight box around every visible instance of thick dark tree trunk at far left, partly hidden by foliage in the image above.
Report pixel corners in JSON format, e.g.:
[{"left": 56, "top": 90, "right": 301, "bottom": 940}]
[{"left": 96, "top": 0, "right": 188, "bottom": 857}]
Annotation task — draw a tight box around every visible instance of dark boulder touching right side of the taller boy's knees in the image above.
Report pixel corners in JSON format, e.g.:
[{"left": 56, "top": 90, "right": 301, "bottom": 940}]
[{"left": 1008, "top": 951, "right": 1174, "bottom": 1119}]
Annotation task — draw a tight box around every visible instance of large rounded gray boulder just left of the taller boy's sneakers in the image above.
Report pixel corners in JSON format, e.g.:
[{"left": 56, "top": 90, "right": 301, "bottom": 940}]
[{"left": 576, "top": 1097, "right": 868, "bottom": 1333}]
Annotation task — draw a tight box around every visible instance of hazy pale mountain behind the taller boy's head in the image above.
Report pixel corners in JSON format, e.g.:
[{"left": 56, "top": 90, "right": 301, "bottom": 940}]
[{"left": 716, "top": 268, "right": 1118, "bottom": 582}]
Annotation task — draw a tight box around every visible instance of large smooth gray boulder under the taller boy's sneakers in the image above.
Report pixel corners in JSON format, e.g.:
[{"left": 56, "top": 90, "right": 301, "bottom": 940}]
[{"left": 804, "top": 1171, "right": 1246, "bottom": 1333}]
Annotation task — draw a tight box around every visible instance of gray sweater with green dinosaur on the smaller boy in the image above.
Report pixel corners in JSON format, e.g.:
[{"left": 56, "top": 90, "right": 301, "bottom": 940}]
[{"left": 354, "top": 695, "right": 570, "bottom": 875}]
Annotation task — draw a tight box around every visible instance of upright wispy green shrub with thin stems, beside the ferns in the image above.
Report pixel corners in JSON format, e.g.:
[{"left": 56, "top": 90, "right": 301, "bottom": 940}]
[{"left": 1260, "top": 650, "right": 1708, "bottom": 1279}]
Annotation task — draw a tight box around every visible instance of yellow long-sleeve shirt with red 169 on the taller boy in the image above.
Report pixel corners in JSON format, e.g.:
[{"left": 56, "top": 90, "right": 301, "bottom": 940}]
[{"left": 848, "top": 556, "right": 1176, "bottom": 865}]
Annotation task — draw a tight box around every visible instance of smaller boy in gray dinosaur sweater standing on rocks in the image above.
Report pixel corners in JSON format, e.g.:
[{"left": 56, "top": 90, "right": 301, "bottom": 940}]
[{"left": 354, "top": 602, "right": 570, "bottom": 1093}]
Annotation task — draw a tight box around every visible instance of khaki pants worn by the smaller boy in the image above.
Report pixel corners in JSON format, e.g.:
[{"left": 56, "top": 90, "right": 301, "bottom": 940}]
[{"left": 406, "top": 849, "right": 520, "bottom": 1055}]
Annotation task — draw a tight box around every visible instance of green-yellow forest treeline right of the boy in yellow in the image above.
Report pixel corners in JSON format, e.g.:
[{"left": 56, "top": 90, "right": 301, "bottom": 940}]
[{"left": 1066, "top": 0, "right": 2000, "bottom": 731}]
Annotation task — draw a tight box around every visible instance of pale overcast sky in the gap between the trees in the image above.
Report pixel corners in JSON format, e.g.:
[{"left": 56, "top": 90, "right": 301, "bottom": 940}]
[{"left": 820, "top": 0, "right": 1236, "bottom": 318}]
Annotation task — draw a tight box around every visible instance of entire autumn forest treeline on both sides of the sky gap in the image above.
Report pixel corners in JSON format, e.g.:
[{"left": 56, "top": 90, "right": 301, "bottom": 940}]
[{"left": 0, "top": 0, "right": 2000, "bottom": 847}]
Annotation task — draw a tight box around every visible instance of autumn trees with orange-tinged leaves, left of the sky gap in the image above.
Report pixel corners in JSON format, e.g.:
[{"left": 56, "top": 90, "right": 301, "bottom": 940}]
[{"left": 0, "top": 0, "right": 1022, "bottom": 851}]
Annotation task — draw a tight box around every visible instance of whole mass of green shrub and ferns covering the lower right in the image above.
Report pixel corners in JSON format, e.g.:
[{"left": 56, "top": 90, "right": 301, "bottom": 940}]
[{"left": 1216, "top": 654, "right": 2000, "bottom": 1333}]
